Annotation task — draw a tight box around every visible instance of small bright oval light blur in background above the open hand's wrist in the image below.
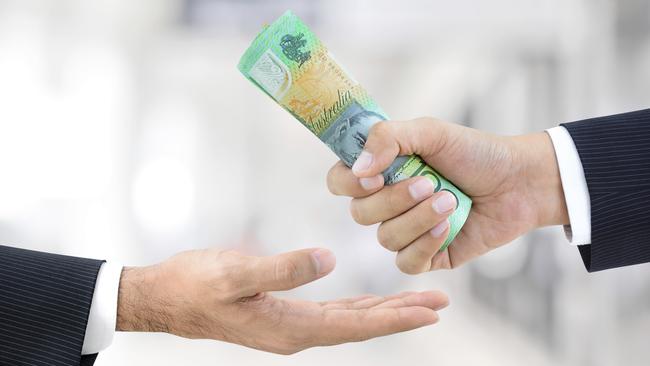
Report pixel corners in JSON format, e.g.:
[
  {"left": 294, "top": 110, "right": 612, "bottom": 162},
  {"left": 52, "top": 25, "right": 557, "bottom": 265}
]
[{"left": 133, "top": 158, "right": 195, "bottom": 235}]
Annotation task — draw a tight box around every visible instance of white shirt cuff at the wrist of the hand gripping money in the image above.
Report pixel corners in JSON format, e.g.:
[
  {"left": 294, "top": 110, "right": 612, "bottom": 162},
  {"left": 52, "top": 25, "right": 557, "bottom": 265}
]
[{"left": 546, "top": 126, "right": 591, "bottom": 245}]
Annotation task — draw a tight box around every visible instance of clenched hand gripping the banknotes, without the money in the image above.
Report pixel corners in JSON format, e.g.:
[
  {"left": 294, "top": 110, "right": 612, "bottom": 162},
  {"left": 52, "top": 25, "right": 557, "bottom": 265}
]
[{"left": 327, "top": 118, "right": 569, "bottom": 274}]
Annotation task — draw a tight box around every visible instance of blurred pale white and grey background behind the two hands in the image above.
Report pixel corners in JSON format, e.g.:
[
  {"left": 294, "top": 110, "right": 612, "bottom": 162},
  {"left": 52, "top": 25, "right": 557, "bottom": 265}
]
[{"left": 0, "top": 0, "right": 650, "bottom": 366}]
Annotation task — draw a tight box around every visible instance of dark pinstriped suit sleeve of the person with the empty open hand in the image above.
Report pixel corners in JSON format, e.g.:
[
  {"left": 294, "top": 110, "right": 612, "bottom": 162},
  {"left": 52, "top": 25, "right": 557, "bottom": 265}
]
[{"left": 0, "top": 246, "right": 102, "bottom": 366}]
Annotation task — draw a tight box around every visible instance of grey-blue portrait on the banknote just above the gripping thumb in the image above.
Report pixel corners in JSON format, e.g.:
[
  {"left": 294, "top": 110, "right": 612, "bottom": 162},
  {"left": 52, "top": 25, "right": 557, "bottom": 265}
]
[{"left": 321, "top": 102, "right": 386, "bottom": 166}]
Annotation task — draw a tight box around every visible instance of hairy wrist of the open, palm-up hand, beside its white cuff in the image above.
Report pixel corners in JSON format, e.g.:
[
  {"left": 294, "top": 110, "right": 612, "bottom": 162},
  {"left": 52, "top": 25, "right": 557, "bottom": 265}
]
[{"left": 116, "top": 266, "right": 170, "bottom": 333}]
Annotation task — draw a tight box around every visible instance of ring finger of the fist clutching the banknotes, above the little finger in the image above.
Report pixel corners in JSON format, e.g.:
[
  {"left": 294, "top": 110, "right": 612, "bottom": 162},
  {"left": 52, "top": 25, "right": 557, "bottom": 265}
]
[{"left": 377, "top": 191, "right": 457, "bottom": 252}]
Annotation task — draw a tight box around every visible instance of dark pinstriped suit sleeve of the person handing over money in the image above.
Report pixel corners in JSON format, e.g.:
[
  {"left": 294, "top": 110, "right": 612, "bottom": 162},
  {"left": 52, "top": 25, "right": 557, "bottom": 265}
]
[{"left": 562, "top": 109, "right": 650, "bottom": 272}]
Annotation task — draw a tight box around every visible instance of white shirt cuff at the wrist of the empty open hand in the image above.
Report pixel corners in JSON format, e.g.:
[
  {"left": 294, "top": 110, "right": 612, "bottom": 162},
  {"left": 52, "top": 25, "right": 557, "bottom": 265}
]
[{"left": 81, "top": 262, "right": 122, "bottom": 355}]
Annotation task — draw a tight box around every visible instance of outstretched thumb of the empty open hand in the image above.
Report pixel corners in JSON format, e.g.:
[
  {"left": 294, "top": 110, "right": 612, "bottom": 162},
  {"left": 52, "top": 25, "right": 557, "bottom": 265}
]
[{"left": 244, "top": 249, "right": 336, "bottom": 292}]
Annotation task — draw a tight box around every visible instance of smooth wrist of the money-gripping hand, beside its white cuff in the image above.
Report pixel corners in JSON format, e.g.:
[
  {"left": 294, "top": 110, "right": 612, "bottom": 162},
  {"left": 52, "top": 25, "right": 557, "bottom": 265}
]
[{"left": 514, "top": 132, "right": 569, "bottom": 227}]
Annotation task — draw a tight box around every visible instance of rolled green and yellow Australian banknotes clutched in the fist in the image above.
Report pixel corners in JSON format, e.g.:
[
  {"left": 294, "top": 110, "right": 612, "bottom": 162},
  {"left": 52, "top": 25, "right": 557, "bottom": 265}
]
[{"left": 238, "top": 11, "right": 472, "bottom": 250}]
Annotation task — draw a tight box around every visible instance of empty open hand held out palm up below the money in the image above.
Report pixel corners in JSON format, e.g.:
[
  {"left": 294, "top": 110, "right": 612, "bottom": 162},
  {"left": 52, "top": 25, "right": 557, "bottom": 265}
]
[{"left": 117, "top": 249, "right": 448, "bottom": 354}]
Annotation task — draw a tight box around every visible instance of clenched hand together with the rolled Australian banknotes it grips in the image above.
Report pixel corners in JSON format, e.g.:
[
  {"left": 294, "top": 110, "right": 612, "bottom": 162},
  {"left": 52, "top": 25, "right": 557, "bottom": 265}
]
[{"left": 239, "top": 12, "right": 568, "bottom": 274}]
